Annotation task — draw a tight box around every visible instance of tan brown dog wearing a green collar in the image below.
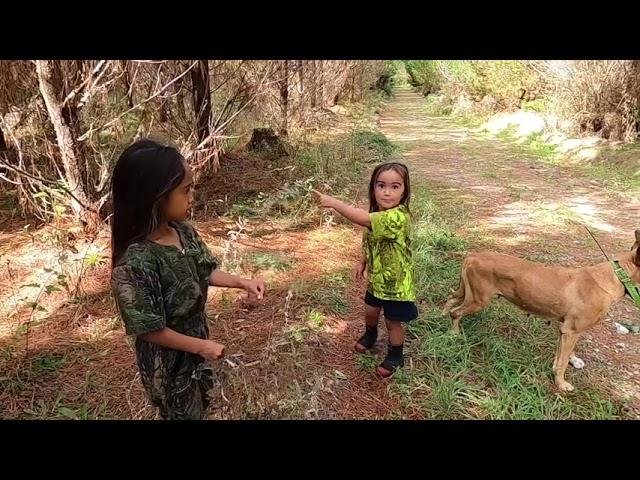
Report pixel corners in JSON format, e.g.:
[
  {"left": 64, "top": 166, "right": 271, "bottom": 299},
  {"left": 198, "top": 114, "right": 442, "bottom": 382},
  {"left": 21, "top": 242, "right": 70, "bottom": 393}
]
[{"left": 444, "top": 230, "right": 640, "bottom": 391}]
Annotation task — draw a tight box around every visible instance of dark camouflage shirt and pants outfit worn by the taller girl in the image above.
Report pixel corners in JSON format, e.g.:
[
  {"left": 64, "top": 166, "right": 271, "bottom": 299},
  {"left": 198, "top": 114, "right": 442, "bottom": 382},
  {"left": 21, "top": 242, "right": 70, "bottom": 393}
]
[{"left": 111, "top": 223, "right": 218, "bottom": 418}]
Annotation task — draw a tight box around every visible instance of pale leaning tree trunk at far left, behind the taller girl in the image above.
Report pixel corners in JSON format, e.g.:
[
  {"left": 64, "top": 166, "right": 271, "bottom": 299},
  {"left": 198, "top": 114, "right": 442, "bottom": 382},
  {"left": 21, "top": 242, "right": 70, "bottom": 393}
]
[{"left": 36, "top": 60, "right": 89, "bottom": 219}]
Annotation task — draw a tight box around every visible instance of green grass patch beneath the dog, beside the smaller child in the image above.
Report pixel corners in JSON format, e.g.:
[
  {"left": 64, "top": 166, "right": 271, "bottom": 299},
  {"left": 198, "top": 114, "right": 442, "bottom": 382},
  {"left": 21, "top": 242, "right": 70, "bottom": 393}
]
[{"left": 388, "top": 185, "right": 622, "bottom": 419}]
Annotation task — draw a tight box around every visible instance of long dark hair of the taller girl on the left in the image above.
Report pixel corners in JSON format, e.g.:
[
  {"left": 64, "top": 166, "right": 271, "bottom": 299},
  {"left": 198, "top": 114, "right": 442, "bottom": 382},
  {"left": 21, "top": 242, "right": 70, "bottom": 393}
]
[{"left": 111, "top": 139, "right": 186, "bottom": 267}]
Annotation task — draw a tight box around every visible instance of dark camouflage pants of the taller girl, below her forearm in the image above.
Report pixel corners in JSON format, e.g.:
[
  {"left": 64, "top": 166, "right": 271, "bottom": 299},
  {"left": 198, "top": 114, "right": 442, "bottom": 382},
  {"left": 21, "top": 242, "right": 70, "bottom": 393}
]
[{"left": 136, "top": 341, "right": 214, "bottom": 420}]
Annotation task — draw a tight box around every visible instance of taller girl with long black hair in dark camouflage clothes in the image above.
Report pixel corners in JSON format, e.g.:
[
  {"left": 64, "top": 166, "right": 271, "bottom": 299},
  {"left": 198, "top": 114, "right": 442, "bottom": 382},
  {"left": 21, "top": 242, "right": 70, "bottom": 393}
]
[{"left": 111, "top": 140, "right": 265, "bottom": 419}]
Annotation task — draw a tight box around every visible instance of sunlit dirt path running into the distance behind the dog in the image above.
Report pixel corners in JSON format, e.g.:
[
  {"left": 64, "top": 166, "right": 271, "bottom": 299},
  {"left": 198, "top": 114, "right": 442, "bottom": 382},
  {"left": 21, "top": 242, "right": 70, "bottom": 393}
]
[{"left": 379, "top": 87, "right": 640, "bottom": 411}]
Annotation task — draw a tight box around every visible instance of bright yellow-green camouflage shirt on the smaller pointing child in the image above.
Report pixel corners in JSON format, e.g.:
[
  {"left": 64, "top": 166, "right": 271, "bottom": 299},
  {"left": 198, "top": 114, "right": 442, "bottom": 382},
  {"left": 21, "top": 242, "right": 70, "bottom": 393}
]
[{"left": 362, "top": 205, "right": 416, "bottom": 302}]
